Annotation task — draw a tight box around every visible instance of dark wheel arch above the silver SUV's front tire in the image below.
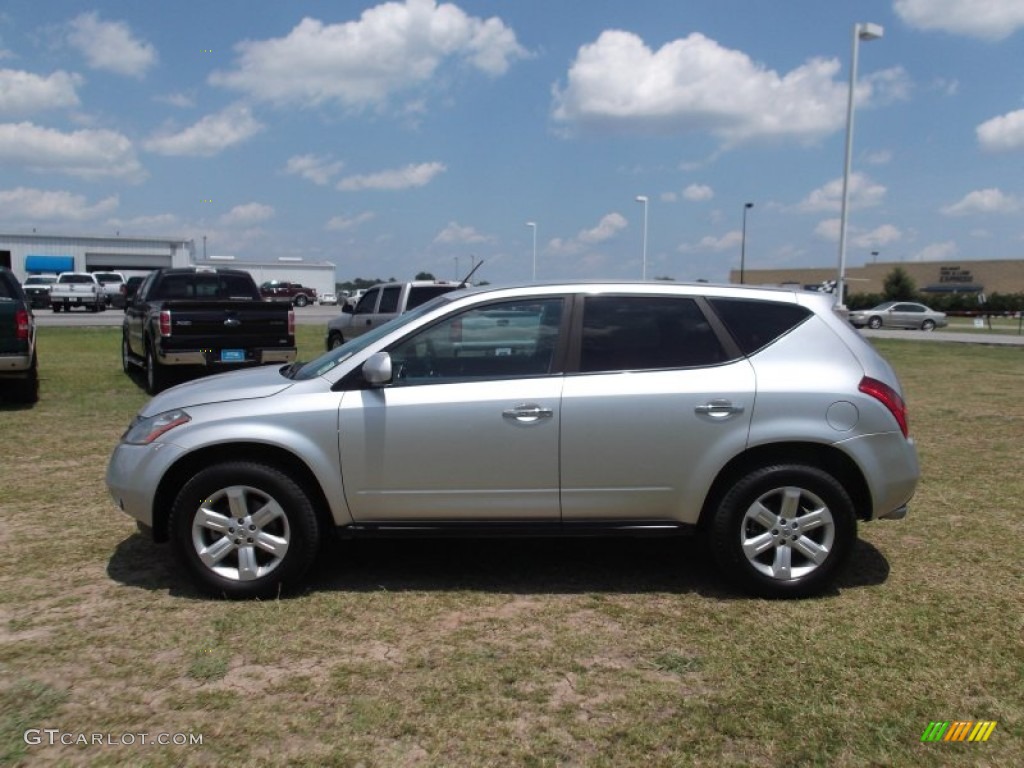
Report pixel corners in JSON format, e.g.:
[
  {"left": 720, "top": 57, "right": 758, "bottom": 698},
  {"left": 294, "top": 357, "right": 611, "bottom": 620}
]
[{"left": 153, "top": 442, "right": 336, "bottom": 542}]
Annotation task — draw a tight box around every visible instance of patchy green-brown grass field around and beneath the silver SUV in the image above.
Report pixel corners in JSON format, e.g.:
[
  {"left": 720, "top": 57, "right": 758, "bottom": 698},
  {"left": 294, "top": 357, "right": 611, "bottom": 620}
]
[{"left": 0, "top": 327, "right": 1024, "bottom": 767}]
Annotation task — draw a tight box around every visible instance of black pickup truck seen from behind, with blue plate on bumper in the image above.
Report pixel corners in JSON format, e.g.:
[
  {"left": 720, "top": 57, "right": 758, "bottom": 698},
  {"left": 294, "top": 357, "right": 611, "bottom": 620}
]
[{"left": 121, "top": 267, "right": 295, "bottom": 394}]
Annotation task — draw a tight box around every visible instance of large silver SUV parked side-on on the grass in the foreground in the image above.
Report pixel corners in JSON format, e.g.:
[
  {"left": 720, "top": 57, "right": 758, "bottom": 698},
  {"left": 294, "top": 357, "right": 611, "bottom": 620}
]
[{"left": 106, "top": 284, "right": 919, "bottom": 597}]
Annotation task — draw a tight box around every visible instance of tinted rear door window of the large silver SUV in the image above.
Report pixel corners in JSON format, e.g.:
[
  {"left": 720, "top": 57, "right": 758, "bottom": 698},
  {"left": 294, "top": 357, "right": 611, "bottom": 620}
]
[{"left": 580, "top": 296, "right": 727, "bottom": 373}]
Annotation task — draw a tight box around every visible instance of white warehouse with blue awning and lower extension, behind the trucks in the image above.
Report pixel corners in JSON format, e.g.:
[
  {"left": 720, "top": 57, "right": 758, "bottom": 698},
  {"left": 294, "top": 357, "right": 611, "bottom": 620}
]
[{"left": 0, "top": 232, "right": 335, "bottom": 293}]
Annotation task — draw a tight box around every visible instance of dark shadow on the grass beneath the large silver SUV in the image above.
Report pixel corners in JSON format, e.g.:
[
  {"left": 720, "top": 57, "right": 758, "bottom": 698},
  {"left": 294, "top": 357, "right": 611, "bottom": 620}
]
[{"left": 108, "top": 534, "right": 890, "bottom": 600}]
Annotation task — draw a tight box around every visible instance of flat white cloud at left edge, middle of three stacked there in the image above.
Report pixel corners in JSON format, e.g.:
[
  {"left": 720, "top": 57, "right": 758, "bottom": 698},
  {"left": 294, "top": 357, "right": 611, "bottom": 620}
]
[{"left": 0, "top": 123, "right": 145, "bottom": 181}]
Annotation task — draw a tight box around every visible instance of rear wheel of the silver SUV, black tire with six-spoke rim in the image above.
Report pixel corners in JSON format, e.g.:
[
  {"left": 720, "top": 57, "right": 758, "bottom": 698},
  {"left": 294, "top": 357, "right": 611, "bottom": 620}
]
[{"left": 708, "top": 464, "right": 857, "bottom": 598}]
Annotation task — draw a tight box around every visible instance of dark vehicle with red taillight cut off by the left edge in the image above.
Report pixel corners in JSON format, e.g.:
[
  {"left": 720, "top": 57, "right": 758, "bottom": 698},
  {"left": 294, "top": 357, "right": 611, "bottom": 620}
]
[{"left": 0, "top": 266, "right": 39, "bottom": 402}]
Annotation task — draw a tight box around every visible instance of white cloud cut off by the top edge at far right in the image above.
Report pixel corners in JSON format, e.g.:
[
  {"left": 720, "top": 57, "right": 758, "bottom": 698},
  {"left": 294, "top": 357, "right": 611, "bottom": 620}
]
[{"left": 893, "top": 0, "right": 1024, "bottom": 41}]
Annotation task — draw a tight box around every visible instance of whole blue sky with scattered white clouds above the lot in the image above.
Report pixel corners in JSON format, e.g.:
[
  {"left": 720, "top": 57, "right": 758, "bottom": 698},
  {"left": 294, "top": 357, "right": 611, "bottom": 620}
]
[{"left": 0, "top": 0, "right": 1024, "bottom": 283}]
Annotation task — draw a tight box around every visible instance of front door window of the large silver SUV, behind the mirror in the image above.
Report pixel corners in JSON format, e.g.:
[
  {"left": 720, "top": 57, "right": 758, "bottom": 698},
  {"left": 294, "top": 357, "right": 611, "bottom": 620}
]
[{"left": 388, "top": 298, "right": 564, "bottom": 386}]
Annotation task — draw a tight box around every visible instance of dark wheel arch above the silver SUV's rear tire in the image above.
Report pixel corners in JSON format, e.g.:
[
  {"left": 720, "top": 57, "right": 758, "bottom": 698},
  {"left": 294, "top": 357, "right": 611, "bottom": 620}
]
[{"left": 698, "top": 442, "right": 871, "bottom": 526}]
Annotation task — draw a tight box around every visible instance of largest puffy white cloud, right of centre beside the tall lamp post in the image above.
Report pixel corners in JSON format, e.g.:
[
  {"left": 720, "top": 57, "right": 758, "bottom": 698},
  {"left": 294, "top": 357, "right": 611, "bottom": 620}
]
[{"left": 553, "top": 30, "right": 908, "bottom": 144}]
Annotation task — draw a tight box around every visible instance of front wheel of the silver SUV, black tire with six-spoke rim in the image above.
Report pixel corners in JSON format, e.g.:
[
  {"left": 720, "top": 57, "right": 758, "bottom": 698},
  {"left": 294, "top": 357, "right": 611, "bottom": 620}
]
[{"left": 170, "top": 462, "right": 321, "bottom": 598}]
